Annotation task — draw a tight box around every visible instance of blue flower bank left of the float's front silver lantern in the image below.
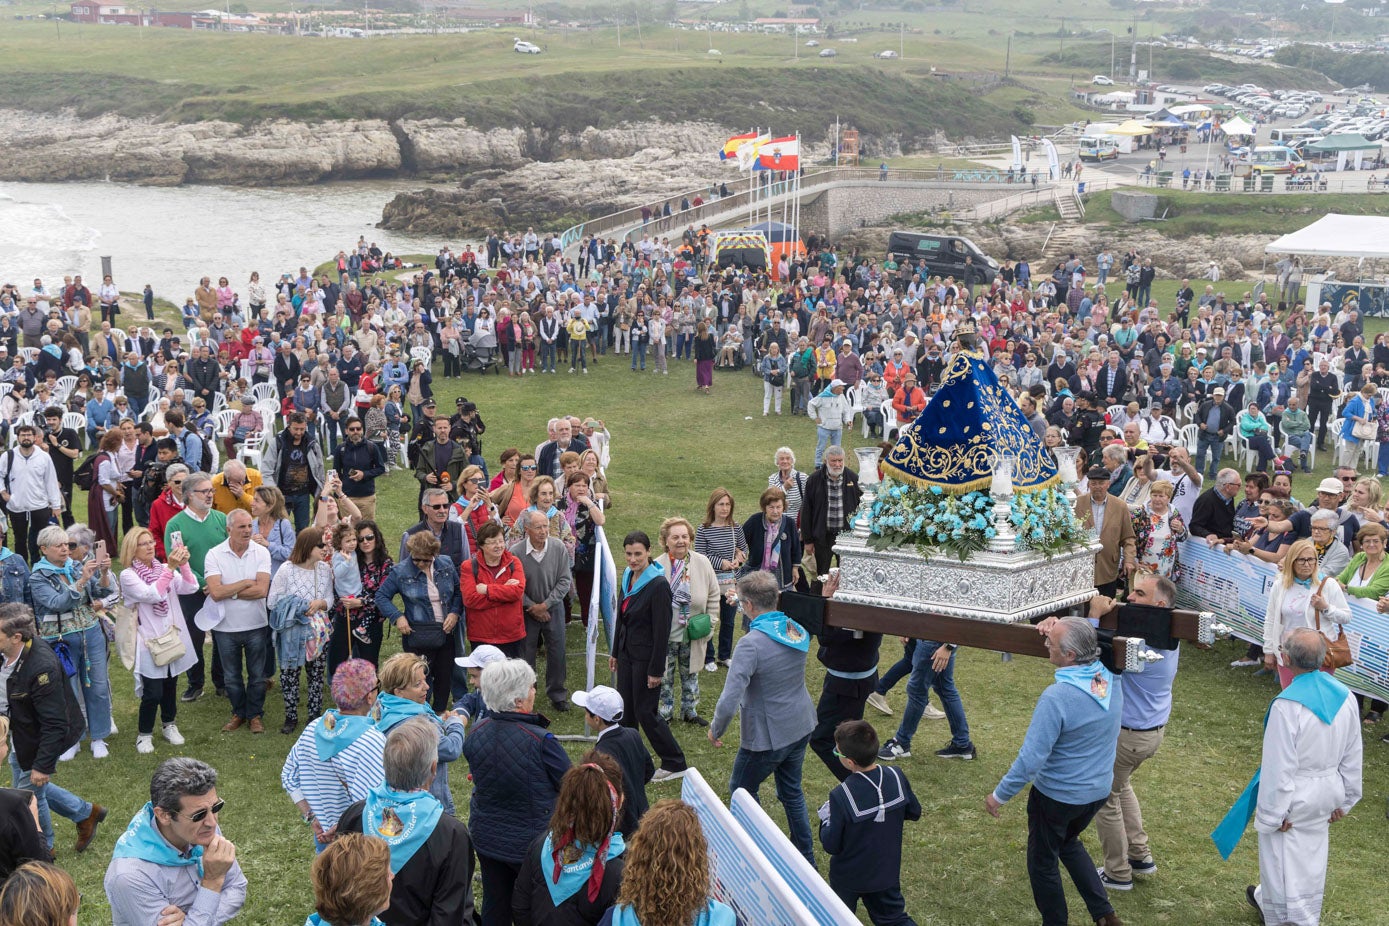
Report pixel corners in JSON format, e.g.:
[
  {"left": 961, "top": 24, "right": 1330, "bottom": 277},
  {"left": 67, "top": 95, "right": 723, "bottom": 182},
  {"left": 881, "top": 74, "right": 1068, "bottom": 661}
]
[{"left": 868, "top": 480, "right": 999, "bottom": 562}]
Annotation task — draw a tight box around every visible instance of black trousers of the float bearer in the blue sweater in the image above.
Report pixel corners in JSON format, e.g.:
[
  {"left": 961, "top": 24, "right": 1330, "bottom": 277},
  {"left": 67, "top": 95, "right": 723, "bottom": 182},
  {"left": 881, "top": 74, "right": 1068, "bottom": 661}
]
[{"left": 1028, "top": 786, "right": 1114, "bottom": 926}]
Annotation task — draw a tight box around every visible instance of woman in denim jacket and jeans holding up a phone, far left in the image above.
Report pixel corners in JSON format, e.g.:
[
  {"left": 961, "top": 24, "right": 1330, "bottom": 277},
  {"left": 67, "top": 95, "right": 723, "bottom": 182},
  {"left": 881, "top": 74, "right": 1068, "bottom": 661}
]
[{"left": 29, "top": 525, "right": 115, "bottom": 759}]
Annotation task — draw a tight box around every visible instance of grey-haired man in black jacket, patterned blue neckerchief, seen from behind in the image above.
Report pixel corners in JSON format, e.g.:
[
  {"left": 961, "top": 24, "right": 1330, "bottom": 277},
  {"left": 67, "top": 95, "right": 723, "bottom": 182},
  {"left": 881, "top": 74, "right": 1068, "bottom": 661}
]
[{"left": 338, "top": 718, "right": 477, "bottom": 923}]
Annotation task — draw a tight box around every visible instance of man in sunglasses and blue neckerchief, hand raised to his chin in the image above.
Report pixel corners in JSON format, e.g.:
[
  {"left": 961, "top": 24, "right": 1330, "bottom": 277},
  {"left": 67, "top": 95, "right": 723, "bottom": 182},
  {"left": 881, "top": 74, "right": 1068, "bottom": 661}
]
[{"left": 106, "top": 758, "right": 246, "bottom": 926}]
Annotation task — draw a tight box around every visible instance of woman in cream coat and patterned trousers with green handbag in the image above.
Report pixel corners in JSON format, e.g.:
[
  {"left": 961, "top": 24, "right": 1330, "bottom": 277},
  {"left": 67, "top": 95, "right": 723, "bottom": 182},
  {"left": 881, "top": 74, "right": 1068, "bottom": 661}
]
[{"left": 656, "top": 518, "right": 720, "bottom": 726}]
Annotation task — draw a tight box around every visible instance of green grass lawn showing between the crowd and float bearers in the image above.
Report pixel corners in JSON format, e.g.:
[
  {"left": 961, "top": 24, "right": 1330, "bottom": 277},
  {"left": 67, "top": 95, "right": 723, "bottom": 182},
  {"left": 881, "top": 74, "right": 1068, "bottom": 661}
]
[{"left": 46, "top": 342, "right": 1389, "bottom": 926}]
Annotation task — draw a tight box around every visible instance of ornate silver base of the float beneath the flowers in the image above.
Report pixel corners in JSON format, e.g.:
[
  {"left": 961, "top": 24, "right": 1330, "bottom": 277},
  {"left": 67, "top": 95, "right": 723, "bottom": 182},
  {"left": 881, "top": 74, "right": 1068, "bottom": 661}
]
[{"left": 835, "top": 532, "right": 1100, "bottom": 623}]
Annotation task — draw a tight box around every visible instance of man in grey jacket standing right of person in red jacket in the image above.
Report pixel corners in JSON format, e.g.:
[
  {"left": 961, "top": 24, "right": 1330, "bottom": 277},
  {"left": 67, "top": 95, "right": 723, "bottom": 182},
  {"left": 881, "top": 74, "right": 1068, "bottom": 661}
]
[{"left": 511, "top": 511, "right": 574, "bottom": 712}]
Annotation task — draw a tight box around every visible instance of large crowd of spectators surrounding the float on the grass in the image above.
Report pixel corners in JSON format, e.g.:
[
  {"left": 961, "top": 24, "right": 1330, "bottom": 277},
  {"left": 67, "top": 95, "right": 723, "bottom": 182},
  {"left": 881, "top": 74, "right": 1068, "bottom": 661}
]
[{"left": 0, "top": 228, "right": 1389, "bottom": 926}]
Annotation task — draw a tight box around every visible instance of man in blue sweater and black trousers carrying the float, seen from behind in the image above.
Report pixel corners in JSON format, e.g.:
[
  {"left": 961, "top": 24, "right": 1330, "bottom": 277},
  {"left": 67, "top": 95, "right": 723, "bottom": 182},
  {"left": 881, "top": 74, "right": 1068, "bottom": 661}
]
[{"left": 983, "top": 618, "right": 1124, "bottom": 926}]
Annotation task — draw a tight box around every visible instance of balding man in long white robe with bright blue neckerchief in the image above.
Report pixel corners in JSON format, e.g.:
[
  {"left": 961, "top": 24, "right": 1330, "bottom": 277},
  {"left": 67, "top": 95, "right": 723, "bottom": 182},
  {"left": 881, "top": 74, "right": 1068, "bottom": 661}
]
[{"left": 1246, "top": 628, "right": 1361, "bottom": 926}]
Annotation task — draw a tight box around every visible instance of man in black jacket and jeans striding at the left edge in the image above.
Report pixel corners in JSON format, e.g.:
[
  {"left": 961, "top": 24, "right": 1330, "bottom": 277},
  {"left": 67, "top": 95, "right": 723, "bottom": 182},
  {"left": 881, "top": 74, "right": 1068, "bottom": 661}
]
[{"left": 0, "top": 603, "right": 106, "bottom": 852}]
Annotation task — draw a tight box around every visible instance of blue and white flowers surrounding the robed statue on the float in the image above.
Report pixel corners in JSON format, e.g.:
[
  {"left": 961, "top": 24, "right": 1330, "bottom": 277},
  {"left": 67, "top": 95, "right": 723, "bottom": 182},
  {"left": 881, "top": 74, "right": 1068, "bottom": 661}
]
[{"left": 868, "top": 480, "right": 1088, "bottom": 562}]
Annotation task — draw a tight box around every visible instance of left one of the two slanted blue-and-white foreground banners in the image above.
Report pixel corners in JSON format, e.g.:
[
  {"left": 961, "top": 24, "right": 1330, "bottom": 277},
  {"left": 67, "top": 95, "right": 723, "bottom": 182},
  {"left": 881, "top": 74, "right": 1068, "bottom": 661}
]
[{"left": 681, "top": 769, "right": 816, "bottom": 926}]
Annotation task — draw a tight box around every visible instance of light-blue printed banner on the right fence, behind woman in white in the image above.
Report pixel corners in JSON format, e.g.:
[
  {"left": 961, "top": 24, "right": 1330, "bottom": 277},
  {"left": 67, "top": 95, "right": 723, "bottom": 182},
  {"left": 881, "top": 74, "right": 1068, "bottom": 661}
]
[{"left": 1176, "top": 539, "right": 1389, "bottom": 700}]
